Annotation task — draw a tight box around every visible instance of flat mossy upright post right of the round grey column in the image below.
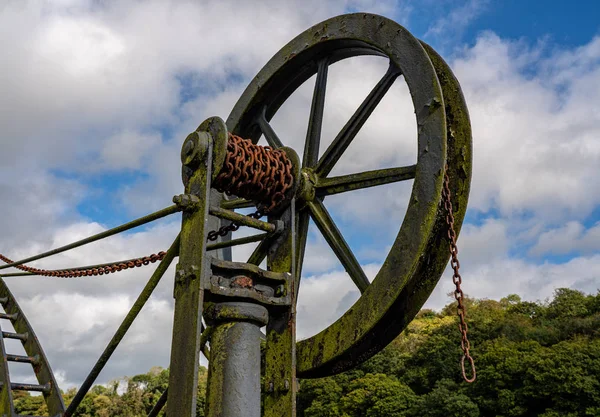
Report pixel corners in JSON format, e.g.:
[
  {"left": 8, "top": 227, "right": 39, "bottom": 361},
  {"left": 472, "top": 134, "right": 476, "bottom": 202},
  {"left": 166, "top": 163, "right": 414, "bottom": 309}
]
[{"left": 263, "top": 200, "right": 298, "bottom": 417}]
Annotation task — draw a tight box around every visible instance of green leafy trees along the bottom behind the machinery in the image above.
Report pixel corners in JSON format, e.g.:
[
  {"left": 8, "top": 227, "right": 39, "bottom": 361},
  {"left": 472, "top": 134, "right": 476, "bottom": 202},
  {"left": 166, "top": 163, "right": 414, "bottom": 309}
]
[{"left": 14, "top": 288, "right": 600, "bottom": 417}]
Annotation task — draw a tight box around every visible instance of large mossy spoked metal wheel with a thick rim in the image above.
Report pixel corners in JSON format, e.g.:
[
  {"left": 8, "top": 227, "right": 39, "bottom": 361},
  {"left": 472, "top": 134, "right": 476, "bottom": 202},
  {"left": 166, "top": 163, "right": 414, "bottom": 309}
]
[{"left": 227, "top": 13, "right": 472, "bottom": 378}]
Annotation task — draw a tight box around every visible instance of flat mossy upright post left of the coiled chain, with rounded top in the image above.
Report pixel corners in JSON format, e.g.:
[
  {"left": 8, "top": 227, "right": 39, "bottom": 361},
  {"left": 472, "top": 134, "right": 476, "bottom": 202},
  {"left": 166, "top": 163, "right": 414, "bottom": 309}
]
[{"left": 167, "top": 132, "right": 213, "bottom": 417}]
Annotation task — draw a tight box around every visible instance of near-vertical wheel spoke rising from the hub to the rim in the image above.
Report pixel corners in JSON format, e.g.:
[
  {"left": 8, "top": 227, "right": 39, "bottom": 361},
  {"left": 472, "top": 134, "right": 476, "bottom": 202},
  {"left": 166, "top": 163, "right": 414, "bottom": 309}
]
[{"left": 302, "top": 58, "right": 329, "bottom": 167}]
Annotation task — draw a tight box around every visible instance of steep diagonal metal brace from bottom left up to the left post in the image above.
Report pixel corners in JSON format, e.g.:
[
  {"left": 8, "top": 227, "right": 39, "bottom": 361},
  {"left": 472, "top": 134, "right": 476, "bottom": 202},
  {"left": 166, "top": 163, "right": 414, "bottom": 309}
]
[{"left": 64, "top": 235, "right": 180, "bottom": 417}]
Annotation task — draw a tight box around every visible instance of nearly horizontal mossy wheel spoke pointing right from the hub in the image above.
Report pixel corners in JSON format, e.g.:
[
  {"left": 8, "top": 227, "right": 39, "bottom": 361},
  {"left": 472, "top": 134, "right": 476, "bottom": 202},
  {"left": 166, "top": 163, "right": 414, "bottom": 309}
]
[{"left": 315, "top": 165, "right": 417, "bottom": 197}]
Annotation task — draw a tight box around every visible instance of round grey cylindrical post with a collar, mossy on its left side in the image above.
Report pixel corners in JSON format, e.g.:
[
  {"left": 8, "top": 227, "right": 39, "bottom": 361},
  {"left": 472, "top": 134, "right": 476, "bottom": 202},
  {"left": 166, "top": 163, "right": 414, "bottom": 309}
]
[{"left": 205, "top": 302, "right": 269, "bottom": 417}]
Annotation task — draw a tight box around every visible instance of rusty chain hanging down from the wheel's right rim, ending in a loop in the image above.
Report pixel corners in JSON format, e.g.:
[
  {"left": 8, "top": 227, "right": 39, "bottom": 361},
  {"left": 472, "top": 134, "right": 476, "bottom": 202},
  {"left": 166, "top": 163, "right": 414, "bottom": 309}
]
[{"left": 442, "top": 165, "right": 477, "bottom": 383}]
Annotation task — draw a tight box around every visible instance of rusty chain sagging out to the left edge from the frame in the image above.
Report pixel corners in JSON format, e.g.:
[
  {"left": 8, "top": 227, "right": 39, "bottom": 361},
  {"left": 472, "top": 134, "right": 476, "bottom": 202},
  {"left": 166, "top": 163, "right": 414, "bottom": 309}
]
[{"left": 0, "top": 252, "right": 166, "bottom": 278}]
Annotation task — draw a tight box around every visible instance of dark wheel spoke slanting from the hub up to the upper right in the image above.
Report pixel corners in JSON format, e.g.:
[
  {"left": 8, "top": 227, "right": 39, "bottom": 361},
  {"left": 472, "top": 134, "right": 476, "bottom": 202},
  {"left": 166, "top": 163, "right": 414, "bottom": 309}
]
[{"left": 315, "top": 63, "right": 400, "bottom": 177}]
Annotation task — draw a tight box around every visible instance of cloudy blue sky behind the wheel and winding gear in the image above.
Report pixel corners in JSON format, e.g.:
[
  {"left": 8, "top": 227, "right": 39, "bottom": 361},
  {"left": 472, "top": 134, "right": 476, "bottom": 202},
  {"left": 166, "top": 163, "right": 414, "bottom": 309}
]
[{"left": 0, "top": 0, "right": 600, "bottom": 389}]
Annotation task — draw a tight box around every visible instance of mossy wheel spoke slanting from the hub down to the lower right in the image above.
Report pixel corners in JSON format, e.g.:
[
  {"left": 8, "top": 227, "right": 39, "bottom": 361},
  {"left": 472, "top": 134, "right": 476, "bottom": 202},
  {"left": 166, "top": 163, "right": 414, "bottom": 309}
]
[{"left": 308, "top": 199, "right": 369, "bottom": 293}]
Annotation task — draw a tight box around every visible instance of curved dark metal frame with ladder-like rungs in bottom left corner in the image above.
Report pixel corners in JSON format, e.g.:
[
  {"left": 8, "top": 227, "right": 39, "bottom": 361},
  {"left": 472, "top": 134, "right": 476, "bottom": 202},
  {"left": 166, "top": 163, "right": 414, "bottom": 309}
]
[{"left": 0, "top": 279, "right": 65, "bottom": 416}]
